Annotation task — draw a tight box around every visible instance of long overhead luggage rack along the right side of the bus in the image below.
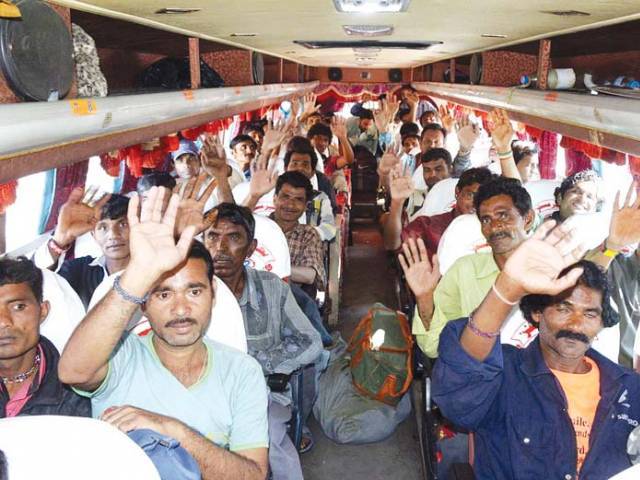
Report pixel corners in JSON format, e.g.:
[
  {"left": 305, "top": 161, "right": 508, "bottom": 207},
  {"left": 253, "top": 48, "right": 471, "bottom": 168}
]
[{"left": 413, "top": 82, "right": 640, "bottom": 155}]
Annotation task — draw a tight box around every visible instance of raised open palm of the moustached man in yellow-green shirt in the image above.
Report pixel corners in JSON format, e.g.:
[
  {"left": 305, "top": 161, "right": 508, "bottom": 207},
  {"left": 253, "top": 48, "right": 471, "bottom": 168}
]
[{"left": 398, "top": 238, "right": 441, "bottom": 298}]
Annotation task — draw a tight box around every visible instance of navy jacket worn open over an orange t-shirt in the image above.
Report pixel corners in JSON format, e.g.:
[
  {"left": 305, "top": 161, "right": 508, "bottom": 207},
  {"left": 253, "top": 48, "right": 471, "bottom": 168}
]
[{"left": 433, "top": 319, "right": 640, "bottom": 480}]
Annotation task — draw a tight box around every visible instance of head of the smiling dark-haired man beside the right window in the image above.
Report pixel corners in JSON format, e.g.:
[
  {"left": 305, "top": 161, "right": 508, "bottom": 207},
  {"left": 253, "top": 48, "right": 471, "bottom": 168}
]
[{"left": 551, "top": 170, "right": 600, "bottom": 222}]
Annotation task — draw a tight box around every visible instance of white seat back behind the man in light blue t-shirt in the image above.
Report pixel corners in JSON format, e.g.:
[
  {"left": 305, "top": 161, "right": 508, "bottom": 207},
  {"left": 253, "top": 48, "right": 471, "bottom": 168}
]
[{"left": 89, "top": 272, "right": 247, "bottom": 353}]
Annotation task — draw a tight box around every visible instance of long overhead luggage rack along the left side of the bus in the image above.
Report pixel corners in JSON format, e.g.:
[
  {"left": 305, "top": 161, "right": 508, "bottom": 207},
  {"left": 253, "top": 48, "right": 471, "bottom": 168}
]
[{"left": 0, "top": 82, "right": 318, "bottom": 182}]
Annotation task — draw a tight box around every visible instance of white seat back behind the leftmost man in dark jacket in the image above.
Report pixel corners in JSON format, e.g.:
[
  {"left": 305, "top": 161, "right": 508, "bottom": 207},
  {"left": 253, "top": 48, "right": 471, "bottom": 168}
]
[{"left": 40, "top": 268, "right": 85, "bottom": 352}]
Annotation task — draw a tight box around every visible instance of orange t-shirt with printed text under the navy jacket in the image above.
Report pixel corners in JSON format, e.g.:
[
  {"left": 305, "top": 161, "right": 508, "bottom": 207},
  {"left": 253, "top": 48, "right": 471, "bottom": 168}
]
[{"left": 551, "top": 357, "right": 600, "bottom": 472}]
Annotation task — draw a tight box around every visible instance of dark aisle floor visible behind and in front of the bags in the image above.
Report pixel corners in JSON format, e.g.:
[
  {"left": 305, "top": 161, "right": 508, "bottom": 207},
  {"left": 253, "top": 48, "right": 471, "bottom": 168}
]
[{"left": 301, "top": 224, "right": 423, "bottom": 480}]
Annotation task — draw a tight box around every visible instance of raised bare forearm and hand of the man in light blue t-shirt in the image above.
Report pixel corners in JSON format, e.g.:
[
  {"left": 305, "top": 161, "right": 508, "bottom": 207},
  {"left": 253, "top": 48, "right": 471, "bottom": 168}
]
[{"left": 58, "top": 187, "right": 195, "bottom": 391}]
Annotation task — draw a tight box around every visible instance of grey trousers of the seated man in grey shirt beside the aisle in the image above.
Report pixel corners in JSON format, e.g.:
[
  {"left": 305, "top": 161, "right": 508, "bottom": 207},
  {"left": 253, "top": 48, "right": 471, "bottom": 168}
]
[{"left": 269, "top": 399, "right": 302, "bottom": 480}]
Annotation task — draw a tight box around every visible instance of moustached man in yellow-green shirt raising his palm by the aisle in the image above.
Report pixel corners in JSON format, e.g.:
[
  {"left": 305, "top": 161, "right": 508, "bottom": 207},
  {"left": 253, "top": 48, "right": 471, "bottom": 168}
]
[{"left": 399, "top": 177, "right": 534, "bottom": 358}]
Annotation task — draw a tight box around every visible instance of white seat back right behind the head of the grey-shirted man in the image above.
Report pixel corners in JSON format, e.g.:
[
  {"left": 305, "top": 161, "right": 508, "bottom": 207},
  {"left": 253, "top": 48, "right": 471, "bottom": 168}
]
[{"left": 245, "top": 215, "right": 291, "bottom": 279}]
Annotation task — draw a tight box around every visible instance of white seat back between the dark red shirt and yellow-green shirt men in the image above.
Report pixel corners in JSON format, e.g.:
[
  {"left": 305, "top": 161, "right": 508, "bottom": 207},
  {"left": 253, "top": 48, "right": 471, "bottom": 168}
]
[{"left": 438, "top": 214, "right": 491, "bottom": 275}]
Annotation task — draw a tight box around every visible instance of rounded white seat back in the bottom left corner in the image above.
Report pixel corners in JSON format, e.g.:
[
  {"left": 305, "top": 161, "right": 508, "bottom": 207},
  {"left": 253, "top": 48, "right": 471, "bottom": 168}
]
[{"left": 0, "top": 415, "right": 160, "bottom": 480}]
